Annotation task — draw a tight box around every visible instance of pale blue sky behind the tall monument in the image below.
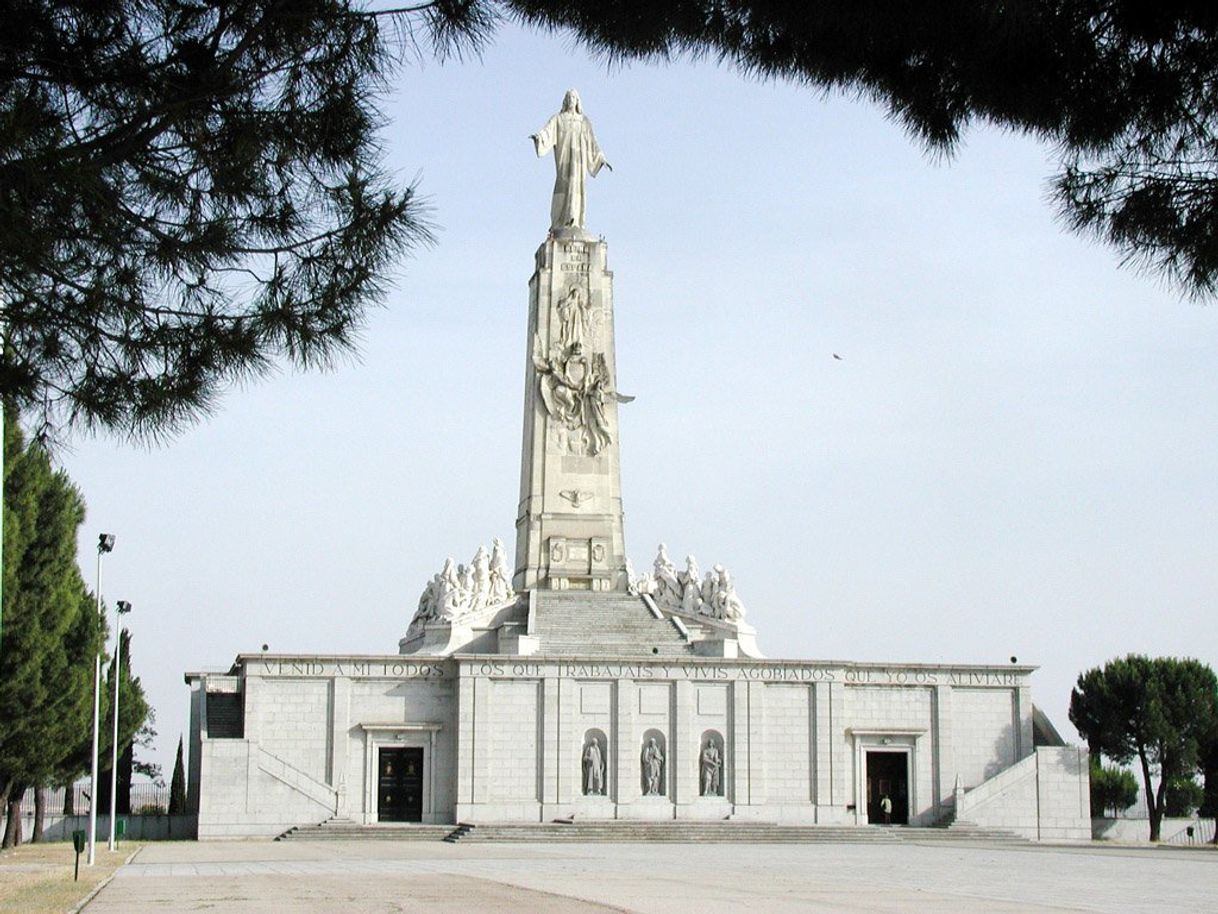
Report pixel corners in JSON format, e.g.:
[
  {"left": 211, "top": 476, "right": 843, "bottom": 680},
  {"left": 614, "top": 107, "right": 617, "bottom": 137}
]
[{"left": 62, "top": 29, "right": 1218, "bottom": 775}]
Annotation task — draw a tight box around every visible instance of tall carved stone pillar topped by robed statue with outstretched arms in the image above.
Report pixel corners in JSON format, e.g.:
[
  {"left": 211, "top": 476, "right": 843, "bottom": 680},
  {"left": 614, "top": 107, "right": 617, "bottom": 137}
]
[{"left": 513, "top": 90, "right": 628, "bottom": 591}]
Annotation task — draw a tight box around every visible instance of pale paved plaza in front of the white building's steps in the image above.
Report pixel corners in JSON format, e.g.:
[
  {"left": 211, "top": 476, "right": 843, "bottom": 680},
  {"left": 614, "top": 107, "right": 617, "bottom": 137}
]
[{"left": 84, "top": 841, "right": 1218, "bottom": 914}]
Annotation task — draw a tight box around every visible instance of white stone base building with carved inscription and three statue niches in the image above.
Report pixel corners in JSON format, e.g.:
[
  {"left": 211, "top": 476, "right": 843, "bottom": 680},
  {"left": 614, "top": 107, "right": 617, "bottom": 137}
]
[{"left": 188, "top": 654, "right": 1090, "bottom": 840}]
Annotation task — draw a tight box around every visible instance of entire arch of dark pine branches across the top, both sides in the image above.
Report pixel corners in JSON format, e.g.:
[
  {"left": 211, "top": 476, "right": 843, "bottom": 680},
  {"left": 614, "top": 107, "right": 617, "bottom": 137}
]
[{"left": 0, "top": 0, "right": 1218, "bottom": 435}]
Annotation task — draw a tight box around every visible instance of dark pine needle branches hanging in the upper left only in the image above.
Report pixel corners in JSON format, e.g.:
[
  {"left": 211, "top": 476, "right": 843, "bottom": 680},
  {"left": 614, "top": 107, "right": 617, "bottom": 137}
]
[{"left": 0, "top": 0, "right": 438, "bottom": 435}]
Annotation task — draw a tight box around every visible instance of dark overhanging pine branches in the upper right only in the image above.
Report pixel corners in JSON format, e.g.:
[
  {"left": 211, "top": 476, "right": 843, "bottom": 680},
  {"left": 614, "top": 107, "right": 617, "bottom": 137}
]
[{"left": 489, "top": 0, "right": 1218, "bottom": 296}]
